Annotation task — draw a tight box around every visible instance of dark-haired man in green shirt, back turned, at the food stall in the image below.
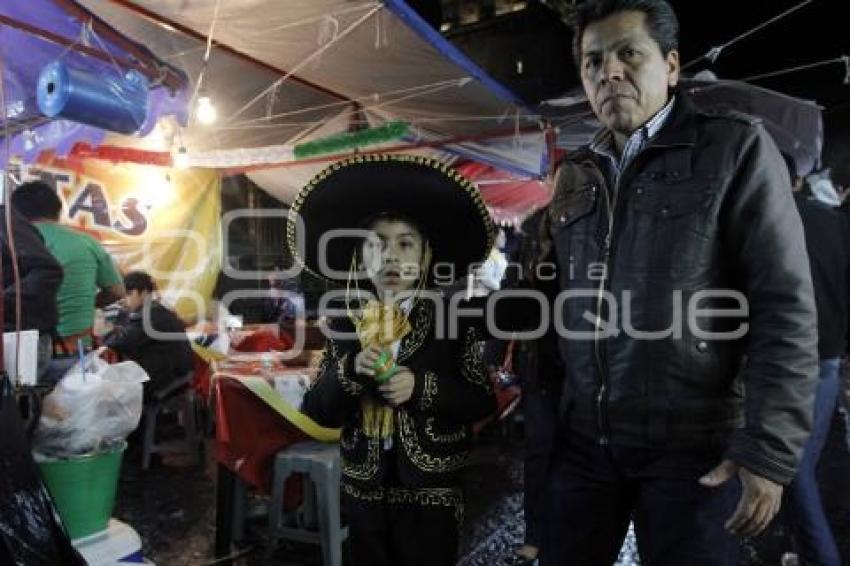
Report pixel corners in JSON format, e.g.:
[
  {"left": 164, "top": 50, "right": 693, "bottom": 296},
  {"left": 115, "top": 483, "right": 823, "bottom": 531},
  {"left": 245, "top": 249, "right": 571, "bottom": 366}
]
[{"left": 12, "top": 181, "right": 125, "bottom": 353}]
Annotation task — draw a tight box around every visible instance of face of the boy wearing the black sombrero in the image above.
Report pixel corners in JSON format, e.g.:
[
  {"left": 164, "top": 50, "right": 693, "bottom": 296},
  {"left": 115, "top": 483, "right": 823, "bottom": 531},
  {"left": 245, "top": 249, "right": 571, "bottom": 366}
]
[{"left": 363, "top": 220, "right": 425, "bottom": 294}]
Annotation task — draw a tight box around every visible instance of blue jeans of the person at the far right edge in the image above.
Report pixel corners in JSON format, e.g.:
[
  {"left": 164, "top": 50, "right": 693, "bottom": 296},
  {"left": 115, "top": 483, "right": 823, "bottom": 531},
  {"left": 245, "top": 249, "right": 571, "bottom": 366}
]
[{"left": 784, "top": 358, "right": 841, "bottom": 566}]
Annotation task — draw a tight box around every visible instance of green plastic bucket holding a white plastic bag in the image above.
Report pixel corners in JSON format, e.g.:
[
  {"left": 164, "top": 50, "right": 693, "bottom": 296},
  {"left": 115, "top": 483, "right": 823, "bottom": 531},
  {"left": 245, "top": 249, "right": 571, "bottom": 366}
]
[{"left": 38, "top": 442, "right": 127, "bottom": 539}]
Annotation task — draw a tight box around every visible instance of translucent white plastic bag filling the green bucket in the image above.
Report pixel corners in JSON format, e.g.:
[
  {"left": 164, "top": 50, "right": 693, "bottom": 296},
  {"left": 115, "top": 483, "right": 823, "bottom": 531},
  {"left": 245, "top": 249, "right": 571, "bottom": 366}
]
[{"left": 33, "top": 352, "right": 148, "bottom": 458}]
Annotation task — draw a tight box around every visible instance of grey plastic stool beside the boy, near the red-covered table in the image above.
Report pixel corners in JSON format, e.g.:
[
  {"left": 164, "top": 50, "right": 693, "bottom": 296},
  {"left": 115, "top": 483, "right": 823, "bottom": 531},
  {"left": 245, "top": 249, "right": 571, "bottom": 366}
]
[{"left": 269, "top": 442, "right": 348, "bottom": 566}]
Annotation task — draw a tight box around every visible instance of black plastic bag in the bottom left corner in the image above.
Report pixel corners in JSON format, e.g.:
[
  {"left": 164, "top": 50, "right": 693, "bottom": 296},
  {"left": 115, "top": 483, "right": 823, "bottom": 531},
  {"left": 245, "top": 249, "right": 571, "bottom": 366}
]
[{"left": 0, "top": 378, "right": 86, "bottom": 566}]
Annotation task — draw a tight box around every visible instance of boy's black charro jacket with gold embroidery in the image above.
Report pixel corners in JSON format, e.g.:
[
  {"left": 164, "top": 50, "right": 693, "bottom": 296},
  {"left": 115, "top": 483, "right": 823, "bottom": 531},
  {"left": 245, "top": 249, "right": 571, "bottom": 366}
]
[{"left": 302, "top": 299, "right": 495, "bottom": 505}]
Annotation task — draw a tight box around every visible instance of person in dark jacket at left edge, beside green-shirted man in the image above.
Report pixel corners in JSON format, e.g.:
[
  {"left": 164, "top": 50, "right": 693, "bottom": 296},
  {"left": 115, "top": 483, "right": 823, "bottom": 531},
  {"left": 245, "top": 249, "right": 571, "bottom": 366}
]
[{"left": 0, "top": 205, "right": 62, "bottom": 379}]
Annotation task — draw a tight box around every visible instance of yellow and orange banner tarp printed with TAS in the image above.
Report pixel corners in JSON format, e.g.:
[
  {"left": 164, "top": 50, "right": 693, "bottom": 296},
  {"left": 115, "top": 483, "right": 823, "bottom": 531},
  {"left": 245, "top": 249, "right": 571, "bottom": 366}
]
[{"left": 8, "top": 156, "right": 221, "bottom": 320}]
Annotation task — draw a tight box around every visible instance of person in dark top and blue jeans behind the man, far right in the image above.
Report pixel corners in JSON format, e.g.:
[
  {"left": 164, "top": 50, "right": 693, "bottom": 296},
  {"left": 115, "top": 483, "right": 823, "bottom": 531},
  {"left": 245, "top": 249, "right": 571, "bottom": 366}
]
[{"left": 783, "top": 161, "right": 850, "bottom": 566}]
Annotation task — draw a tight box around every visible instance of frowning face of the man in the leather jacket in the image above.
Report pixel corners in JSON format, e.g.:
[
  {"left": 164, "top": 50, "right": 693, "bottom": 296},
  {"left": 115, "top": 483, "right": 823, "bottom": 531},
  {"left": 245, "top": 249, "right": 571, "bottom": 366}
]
[{"left": 581, "top": 10, "right": 679, "bottom": 136}]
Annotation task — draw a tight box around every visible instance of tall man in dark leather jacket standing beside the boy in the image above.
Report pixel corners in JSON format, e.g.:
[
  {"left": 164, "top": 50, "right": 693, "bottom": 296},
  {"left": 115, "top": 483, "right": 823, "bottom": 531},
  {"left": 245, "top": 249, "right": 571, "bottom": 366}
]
[{"left": 512, "top": 0, "right": 817, "bottom": 566}]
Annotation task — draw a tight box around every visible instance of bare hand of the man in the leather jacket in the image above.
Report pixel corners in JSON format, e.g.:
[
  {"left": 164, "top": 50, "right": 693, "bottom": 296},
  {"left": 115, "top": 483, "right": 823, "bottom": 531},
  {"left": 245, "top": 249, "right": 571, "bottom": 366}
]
[{"left": 699, "top": 460, "right": 782, "bottom": 536}]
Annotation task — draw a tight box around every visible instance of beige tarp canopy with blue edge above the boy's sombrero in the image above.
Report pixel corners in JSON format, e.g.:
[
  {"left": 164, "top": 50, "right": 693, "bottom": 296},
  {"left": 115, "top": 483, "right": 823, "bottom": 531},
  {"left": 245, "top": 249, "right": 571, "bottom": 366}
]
[{"left": 81, "top": 0, "right": 547, "bottom": 180}]
